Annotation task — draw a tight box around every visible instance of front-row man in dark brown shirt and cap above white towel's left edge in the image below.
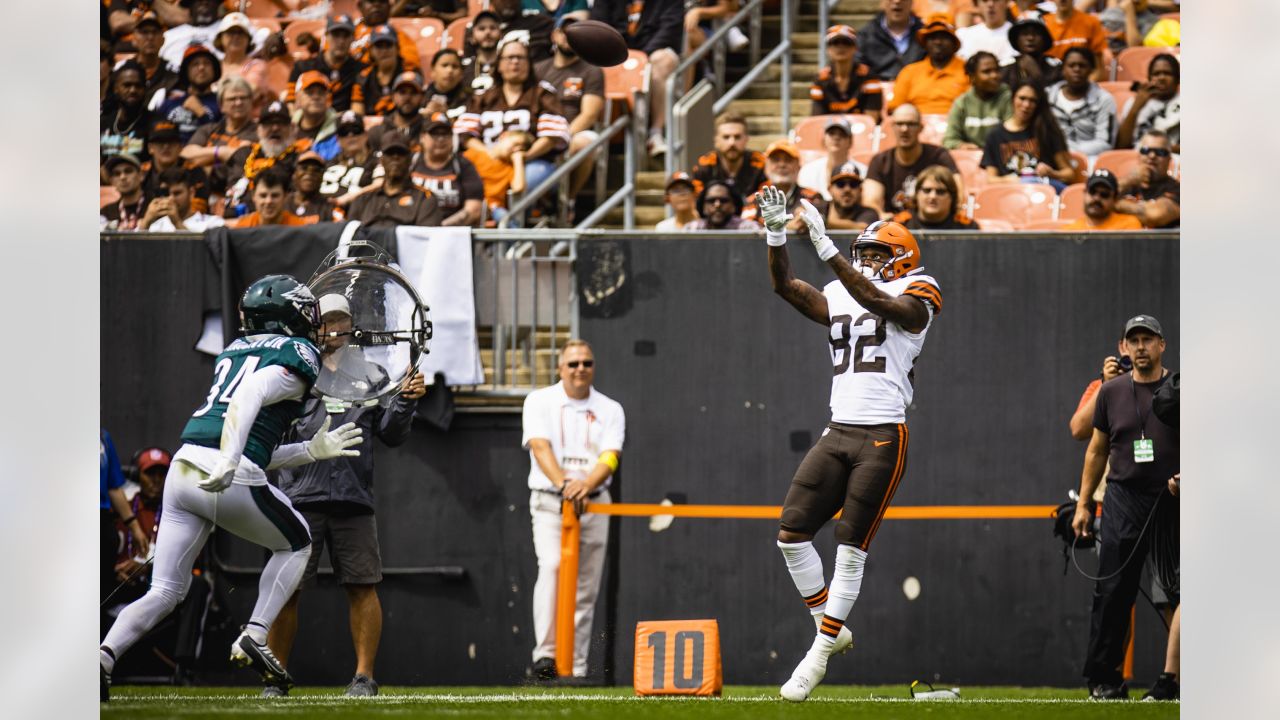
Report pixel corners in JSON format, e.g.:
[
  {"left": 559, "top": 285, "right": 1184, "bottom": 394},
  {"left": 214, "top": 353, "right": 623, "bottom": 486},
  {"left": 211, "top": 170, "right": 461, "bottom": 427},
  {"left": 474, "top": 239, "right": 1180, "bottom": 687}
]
[{"left": 347, "top": 132, "right": 444, "bottom": 228}]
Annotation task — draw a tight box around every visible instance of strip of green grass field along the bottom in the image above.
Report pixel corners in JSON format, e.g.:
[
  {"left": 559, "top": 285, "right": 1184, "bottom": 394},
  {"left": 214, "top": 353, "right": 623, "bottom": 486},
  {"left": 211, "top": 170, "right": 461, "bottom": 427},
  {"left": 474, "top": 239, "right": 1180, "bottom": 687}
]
[{"left": 101, "top": 685, "right": 1179, "bottom": 720}]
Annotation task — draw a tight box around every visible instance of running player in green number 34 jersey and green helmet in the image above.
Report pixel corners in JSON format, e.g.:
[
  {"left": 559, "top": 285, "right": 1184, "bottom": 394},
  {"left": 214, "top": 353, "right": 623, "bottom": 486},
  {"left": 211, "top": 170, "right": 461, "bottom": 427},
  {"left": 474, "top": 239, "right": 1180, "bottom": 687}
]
[{"left": 100, "top": 275, "right": 361, "bottom": 701}]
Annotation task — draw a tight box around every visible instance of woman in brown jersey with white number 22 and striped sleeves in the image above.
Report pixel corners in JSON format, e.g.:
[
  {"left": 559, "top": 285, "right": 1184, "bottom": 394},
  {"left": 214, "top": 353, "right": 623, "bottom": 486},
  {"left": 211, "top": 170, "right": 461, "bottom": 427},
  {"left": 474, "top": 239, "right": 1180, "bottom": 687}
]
[{"left": 453, "top": 37, "right": 570, "bottom": 196}]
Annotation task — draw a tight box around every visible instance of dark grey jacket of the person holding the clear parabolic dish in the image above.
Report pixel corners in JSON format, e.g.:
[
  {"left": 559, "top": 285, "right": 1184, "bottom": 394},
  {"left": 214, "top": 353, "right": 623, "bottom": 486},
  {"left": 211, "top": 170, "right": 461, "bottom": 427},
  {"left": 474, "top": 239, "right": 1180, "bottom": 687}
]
[{"left": 273, "top": 395, "right": 417, "bottom": 512}]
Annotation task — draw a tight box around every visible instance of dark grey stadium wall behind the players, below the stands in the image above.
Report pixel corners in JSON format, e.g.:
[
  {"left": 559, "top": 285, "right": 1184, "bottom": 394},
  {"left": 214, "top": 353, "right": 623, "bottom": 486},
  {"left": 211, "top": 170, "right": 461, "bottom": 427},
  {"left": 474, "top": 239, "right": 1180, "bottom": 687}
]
[{"left": 101, "top": 236, "right": 1179, "bottom": 685}]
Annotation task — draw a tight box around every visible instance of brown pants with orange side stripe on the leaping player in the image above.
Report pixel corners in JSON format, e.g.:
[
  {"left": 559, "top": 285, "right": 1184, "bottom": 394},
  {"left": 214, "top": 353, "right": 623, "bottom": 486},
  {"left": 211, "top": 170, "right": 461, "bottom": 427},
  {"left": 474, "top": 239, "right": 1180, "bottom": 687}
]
[{"left": 782, "top": 423, "right": 908, "bottom": 550}]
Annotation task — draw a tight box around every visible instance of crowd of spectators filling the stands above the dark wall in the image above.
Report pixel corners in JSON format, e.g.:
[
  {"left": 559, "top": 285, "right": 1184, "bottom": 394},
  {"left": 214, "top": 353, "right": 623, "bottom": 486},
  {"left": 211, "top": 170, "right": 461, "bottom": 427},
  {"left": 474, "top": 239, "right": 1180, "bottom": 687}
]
[{"left": 100, "top": 0, "right": 1180, "bottom": 232}]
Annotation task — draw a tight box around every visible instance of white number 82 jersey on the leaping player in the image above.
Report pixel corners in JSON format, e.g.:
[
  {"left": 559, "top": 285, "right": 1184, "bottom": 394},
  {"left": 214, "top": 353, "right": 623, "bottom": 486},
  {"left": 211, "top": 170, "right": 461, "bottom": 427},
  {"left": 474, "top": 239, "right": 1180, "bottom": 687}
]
[{"left": 822, "top": 273, "right": 942, "bottom": 425}]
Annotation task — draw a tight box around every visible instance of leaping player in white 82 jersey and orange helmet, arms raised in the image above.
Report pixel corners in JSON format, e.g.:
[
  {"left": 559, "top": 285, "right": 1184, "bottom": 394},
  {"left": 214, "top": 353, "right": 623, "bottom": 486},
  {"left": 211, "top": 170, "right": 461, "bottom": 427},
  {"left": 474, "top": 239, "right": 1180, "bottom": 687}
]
[{"left": 758, "top": 186, "right": 942, "bottom": 702}]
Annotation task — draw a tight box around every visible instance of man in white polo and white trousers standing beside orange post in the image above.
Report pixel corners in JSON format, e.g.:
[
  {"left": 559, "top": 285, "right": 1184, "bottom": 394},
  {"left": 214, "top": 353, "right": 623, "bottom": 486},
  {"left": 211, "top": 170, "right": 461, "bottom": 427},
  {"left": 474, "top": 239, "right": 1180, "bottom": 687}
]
[{"left": 521, "top": 340, "right": 626, "bottom": 680}]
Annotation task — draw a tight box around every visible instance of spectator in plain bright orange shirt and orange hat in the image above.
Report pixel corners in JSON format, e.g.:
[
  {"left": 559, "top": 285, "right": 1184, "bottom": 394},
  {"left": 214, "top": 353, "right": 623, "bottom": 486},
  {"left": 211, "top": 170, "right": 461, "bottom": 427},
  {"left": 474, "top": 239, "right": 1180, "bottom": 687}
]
[{"left": 888, "top": 15, "right": 969, "bottom": 115}]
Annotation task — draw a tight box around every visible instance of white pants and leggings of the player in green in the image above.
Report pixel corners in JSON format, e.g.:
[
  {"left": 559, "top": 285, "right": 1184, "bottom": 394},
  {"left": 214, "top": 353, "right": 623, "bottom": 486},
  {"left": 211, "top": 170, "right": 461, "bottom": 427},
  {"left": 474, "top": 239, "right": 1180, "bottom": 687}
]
[{"left": 102, "top": 460, "right": 311, "bottom": 659}]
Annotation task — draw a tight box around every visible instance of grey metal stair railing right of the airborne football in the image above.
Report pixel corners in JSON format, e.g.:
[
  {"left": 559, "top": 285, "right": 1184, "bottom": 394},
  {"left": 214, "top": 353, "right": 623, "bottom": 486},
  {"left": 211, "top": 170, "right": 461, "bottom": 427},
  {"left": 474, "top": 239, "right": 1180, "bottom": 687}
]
[{"left": 663, "top": 0, "right": 795, "bottom": 177}]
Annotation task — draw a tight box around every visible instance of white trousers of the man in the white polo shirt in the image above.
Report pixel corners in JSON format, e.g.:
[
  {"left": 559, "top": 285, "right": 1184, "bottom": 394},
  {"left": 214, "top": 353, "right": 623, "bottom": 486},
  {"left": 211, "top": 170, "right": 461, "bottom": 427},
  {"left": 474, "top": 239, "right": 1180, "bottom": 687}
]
[{"left": 529, "top": 491, "right": 612, "bottom": 678}]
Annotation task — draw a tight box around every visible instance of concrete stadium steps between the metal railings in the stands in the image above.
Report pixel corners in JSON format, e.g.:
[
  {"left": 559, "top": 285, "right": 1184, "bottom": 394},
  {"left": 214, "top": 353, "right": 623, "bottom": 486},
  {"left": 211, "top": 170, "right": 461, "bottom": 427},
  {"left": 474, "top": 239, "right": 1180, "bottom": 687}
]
[{"left": 603, "top": 0, "right": 879, "bottom": 229}]
